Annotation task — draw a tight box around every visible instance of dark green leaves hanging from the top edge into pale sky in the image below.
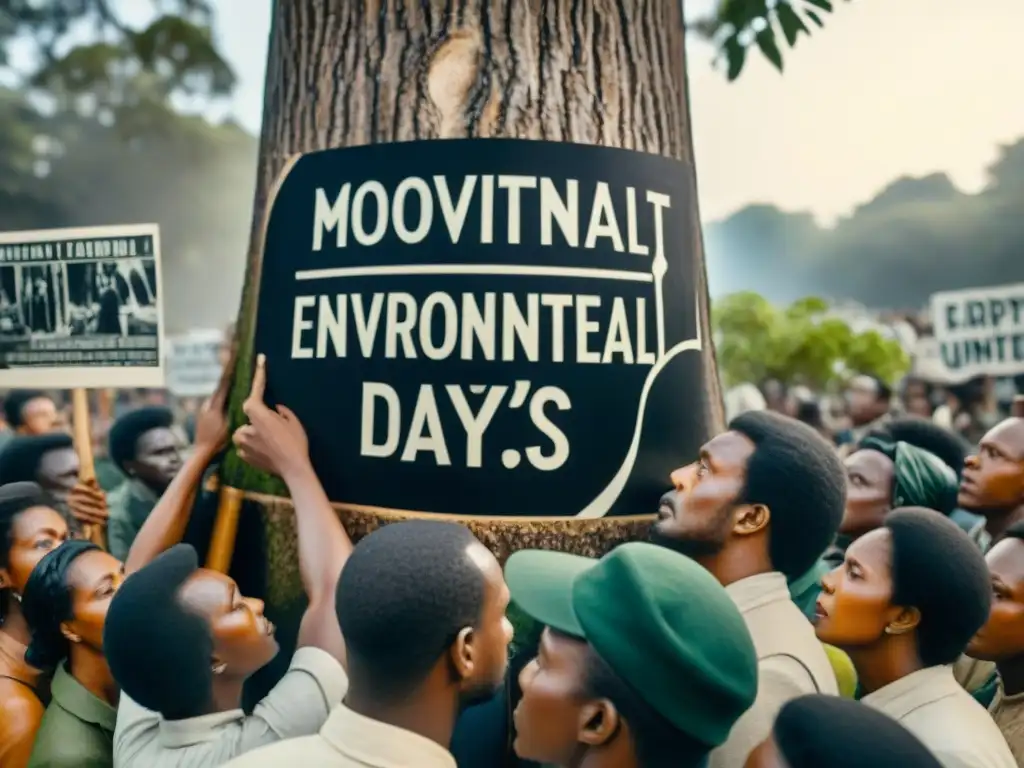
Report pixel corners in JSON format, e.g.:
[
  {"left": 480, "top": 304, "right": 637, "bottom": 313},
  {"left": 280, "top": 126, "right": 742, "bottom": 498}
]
[{"left": 690, "top": 0, "right": 849, "bottom": 80}]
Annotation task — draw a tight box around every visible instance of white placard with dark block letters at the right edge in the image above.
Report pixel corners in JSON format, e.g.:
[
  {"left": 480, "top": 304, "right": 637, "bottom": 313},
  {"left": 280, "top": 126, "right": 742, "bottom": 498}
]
[{"left": 931, "top": 283, "right": 1024, "bottom": 382}]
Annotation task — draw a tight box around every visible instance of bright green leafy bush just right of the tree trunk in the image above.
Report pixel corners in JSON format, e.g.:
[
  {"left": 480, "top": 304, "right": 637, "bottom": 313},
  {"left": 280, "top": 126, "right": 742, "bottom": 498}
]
[{"left": 712, "top": 291, "right": 909, "bottom": 389}]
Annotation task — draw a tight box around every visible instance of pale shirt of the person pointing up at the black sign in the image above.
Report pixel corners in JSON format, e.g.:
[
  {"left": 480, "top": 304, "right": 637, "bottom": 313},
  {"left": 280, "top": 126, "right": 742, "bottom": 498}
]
[{"left": 114, "top": 647, "right": 348, "bottom": 768}]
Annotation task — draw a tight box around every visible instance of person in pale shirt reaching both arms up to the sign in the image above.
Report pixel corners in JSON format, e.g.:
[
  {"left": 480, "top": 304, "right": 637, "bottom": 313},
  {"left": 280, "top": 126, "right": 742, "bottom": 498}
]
[{"left": 103, "top": 355, "right": 351, "bottom": 768}]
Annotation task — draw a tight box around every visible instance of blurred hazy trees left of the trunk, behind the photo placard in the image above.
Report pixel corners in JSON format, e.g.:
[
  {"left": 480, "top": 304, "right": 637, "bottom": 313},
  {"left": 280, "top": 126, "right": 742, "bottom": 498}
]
[{"left": 0, "top": 0, "right": 251, "bottom": 331}]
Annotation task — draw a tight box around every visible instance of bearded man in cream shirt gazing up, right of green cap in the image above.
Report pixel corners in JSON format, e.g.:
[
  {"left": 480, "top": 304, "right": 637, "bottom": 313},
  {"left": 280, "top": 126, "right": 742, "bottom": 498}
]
[{"left": 653, "top": 412, "right": 846, "bottom": 768}]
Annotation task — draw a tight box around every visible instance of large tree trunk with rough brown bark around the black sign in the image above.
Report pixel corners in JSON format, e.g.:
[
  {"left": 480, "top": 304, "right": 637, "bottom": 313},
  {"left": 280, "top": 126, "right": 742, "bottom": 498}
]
[{"left": 224, "top": 0, "right": 722, "bottom": 671}]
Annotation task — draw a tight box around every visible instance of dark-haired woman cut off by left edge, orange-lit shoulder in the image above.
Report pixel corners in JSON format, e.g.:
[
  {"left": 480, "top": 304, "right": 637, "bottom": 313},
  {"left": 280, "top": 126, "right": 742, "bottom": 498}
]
[{"left": 0, "top": 482, "right": 68, "bottom": 768}]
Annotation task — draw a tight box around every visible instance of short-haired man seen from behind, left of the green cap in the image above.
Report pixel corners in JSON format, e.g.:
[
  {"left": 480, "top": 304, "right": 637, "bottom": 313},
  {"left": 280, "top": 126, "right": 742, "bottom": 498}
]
[{"left": 222, "top": 520, "right": 512, "bottom": 768}]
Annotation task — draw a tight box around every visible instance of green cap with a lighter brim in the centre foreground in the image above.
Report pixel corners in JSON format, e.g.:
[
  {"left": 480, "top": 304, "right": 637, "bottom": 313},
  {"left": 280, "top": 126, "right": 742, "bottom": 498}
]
[{"left": 505, "top": 542, "right": 758, "bottom": 748}]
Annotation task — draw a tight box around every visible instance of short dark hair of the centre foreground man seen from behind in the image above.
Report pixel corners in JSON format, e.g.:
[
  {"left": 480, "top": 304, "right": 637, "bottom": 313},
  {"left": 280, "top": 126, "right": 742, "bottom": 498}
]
[{"left": 335, "top": 520, "right": 485, "bottom": 697}]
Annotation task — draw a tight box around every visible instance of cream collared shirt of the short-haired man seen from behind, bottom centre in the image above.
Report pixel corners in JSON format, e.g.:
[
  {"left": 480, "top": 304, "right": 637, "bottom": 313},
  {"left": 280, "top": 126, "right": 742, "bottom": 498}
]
[{"left": 228, "top": 705, "right": 456, "bottom": 768}]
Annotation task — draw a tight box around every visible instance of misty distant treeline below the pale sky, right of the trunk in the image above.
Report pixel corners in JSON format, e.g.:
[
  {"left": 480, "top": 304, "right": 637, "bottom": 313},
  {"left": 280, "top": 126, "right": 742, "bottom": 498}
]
[{"left": 705, "top": 144, "right": 1024, "bottom": 311}]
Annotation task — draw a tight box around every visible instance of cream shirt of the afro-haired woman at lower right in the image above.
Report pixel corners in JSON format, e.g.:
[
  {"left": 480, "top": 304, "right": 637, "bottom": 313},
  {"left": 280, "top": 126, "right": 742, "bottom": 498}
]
[{"left": 860, "top": 667, "right": 1017, "bottom": 768}]
